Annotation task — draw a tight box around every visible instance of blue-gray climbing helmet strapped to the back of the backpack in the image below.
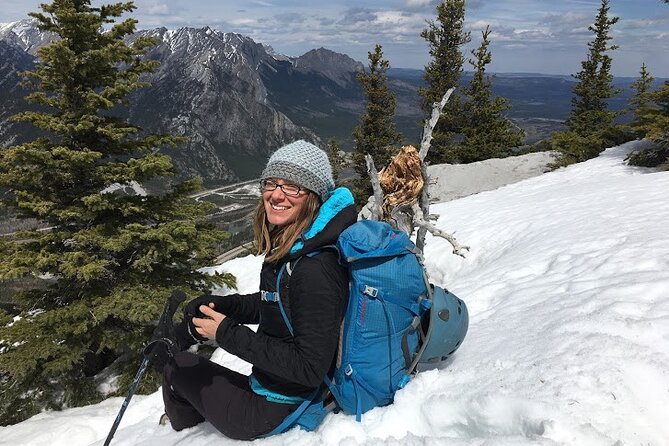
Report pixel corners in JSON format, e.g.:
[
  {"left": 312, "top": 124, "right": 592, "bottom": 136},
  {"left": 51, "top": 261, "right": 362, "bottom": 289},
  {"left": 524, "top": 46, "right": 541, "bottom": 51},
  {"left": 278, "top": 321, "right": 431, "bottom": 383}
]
[{"left": 419, "top": 285, "right": 469, "bottom": 364}]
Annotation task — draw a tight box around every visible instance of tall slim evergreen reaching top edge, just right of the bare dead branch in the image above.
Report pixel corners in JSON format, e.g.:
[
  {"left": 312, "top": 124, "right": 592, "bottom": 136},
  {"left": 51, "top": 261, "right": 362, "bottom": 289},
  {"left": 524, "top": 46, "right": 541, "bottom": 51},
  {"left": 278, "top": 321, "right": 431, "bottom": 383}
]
[{"left": 418, "top": 0, "right": 471, "bottom": 162}]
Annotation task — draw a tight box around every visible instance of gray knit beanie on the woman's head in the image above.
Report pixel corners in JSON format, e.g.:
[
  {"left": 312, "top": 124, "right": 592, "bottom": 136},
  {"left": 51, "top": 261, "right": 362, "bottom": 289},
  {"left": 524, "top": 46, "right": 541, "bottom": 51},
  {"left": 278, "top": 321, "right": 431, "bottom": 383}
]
[{"left": 260, "top": 140, "right": 335, "bottom": 201}]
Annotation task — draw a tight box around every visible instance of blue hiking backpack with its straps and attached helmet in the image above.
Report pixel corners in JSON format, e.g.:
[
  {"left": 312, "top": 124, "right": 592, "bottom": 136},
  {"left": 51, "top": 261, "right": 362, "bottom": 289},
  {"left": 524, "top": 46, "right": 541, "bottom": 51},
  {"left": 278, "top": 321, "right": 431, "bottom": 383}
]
[{"left": 268, "top": 220, "right": 469, "bottom": 436}]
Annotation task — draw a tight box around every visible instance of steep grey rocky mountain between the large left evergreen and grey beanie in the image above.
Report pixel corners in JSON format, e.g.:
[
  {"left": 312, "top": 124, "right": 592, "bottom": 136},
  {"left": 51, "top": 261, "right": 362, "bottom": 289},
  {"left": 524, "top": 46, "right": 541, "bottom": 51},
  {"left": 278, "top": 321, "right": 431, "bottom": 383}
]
[{"left": 129, "top": 28, "right": 318, "bottom": 184}]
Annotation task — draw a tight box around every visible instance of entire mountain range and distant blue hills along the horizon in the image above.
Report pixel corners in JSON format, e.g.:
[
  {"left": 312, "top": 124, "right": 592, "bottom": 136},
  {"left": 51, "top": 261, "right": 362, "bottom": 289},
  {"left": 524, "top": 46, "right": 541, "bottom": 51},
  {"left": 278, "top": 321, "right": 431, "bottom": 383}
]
[{"left": 0, "top": 20, "right": 662, "bottom": 186}]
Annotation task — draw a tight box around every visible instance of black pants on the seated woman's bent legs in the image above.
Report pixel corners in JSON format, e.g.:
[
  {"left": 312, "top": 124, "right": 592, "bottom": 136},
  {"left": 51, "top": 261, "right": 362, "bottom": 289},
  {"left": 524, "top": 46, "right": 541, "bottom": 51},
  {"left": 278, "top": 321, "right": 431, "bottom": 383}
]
[{"left": 163, "top": 352, "right": 297, "bottom": 440}]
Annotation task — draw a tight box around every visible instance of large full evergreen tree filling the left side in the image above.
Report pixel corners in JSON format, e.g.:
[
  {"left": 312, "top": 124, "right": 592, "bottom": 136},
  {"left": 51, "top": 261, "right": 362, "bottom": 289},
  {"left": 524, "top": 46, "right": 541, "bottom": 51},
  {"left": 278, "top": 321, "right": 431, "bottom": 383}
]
[{"left": 0, "top": 0, "right": 234, "bottom": 425}]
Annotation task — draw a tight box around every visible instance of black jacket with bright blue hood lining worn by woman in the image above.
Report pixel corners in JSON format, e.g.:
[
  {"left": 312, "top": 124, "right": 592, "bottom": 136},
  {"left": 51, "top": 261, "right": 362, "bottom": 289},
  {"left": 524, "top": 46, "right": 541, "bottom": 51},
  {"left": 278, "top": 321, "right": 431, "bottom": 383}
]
[{"left": 180, "top": 188, "right": 357, "bottom": 402}]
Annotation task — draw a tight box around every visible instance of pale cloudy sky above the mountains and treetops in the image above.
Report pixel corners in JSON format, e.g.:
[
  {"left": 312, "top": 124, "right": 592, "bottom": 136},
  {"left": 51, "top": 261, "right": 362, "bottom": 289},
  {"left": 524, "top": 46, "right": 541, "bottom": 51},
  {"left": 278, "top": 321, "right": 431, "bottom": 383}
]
[{"left": 0, "top": 0, "right": 669, "bottom": 77}]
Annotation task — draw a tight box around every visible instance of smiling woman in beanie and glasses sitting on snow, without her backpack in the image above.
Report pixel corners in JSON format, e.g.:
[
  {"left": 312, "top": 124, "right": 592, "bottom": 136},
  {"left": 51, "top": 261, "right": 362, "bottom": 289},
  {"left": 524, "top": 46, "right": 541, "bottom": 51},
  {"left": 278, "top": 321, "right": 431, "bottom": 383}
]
[{"left": 152, "top": 141, "right": 356, "bottom": 440}]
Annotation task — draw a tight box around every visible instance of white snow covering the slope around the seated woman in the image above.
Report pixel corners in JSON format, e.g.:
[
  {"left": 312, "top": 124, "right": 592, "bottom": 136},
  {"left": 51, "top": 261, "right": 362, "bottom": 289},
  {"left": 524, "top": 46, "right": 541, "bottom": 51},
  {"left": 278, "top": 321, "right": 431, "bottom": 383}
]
[{"left": 0, "top": 143, "right": 669, "bottom": 446}]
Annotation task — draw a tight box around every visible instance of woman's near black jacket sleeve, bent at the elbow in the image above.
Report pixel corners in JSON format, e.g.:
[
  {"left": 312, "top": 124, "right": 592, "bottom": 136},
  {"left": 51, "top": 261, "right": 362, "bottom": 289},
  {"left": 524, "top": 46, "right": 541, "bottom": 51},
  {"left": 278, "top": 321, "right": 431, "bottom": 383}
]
[{"left": 216, "top": 253, "right": 348, "bottom": 388}]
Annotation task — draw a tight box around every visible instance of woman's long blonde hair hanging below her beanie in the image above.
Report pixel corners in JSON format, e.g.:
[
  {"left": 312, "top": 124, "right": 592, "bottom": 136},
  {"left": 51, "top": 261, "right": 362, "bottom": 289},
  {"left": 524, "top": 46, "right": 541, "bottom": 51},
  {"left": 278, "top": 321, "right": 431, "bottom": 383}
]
[{"left": 253, "top": 191, "right": 321, "bottom": 262}]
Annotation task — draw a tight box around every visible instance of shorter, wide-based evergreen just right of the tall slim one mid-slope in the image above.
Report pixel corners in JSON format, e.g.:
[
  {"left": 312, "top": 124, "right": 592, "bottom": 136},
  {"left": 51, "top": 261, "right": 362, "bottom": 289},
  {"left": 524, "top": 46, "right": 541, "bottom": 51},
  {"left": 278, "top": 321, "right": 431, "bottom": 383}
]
[{"left": 447, "top": 27, "right": 525, "bottom": 163}]
